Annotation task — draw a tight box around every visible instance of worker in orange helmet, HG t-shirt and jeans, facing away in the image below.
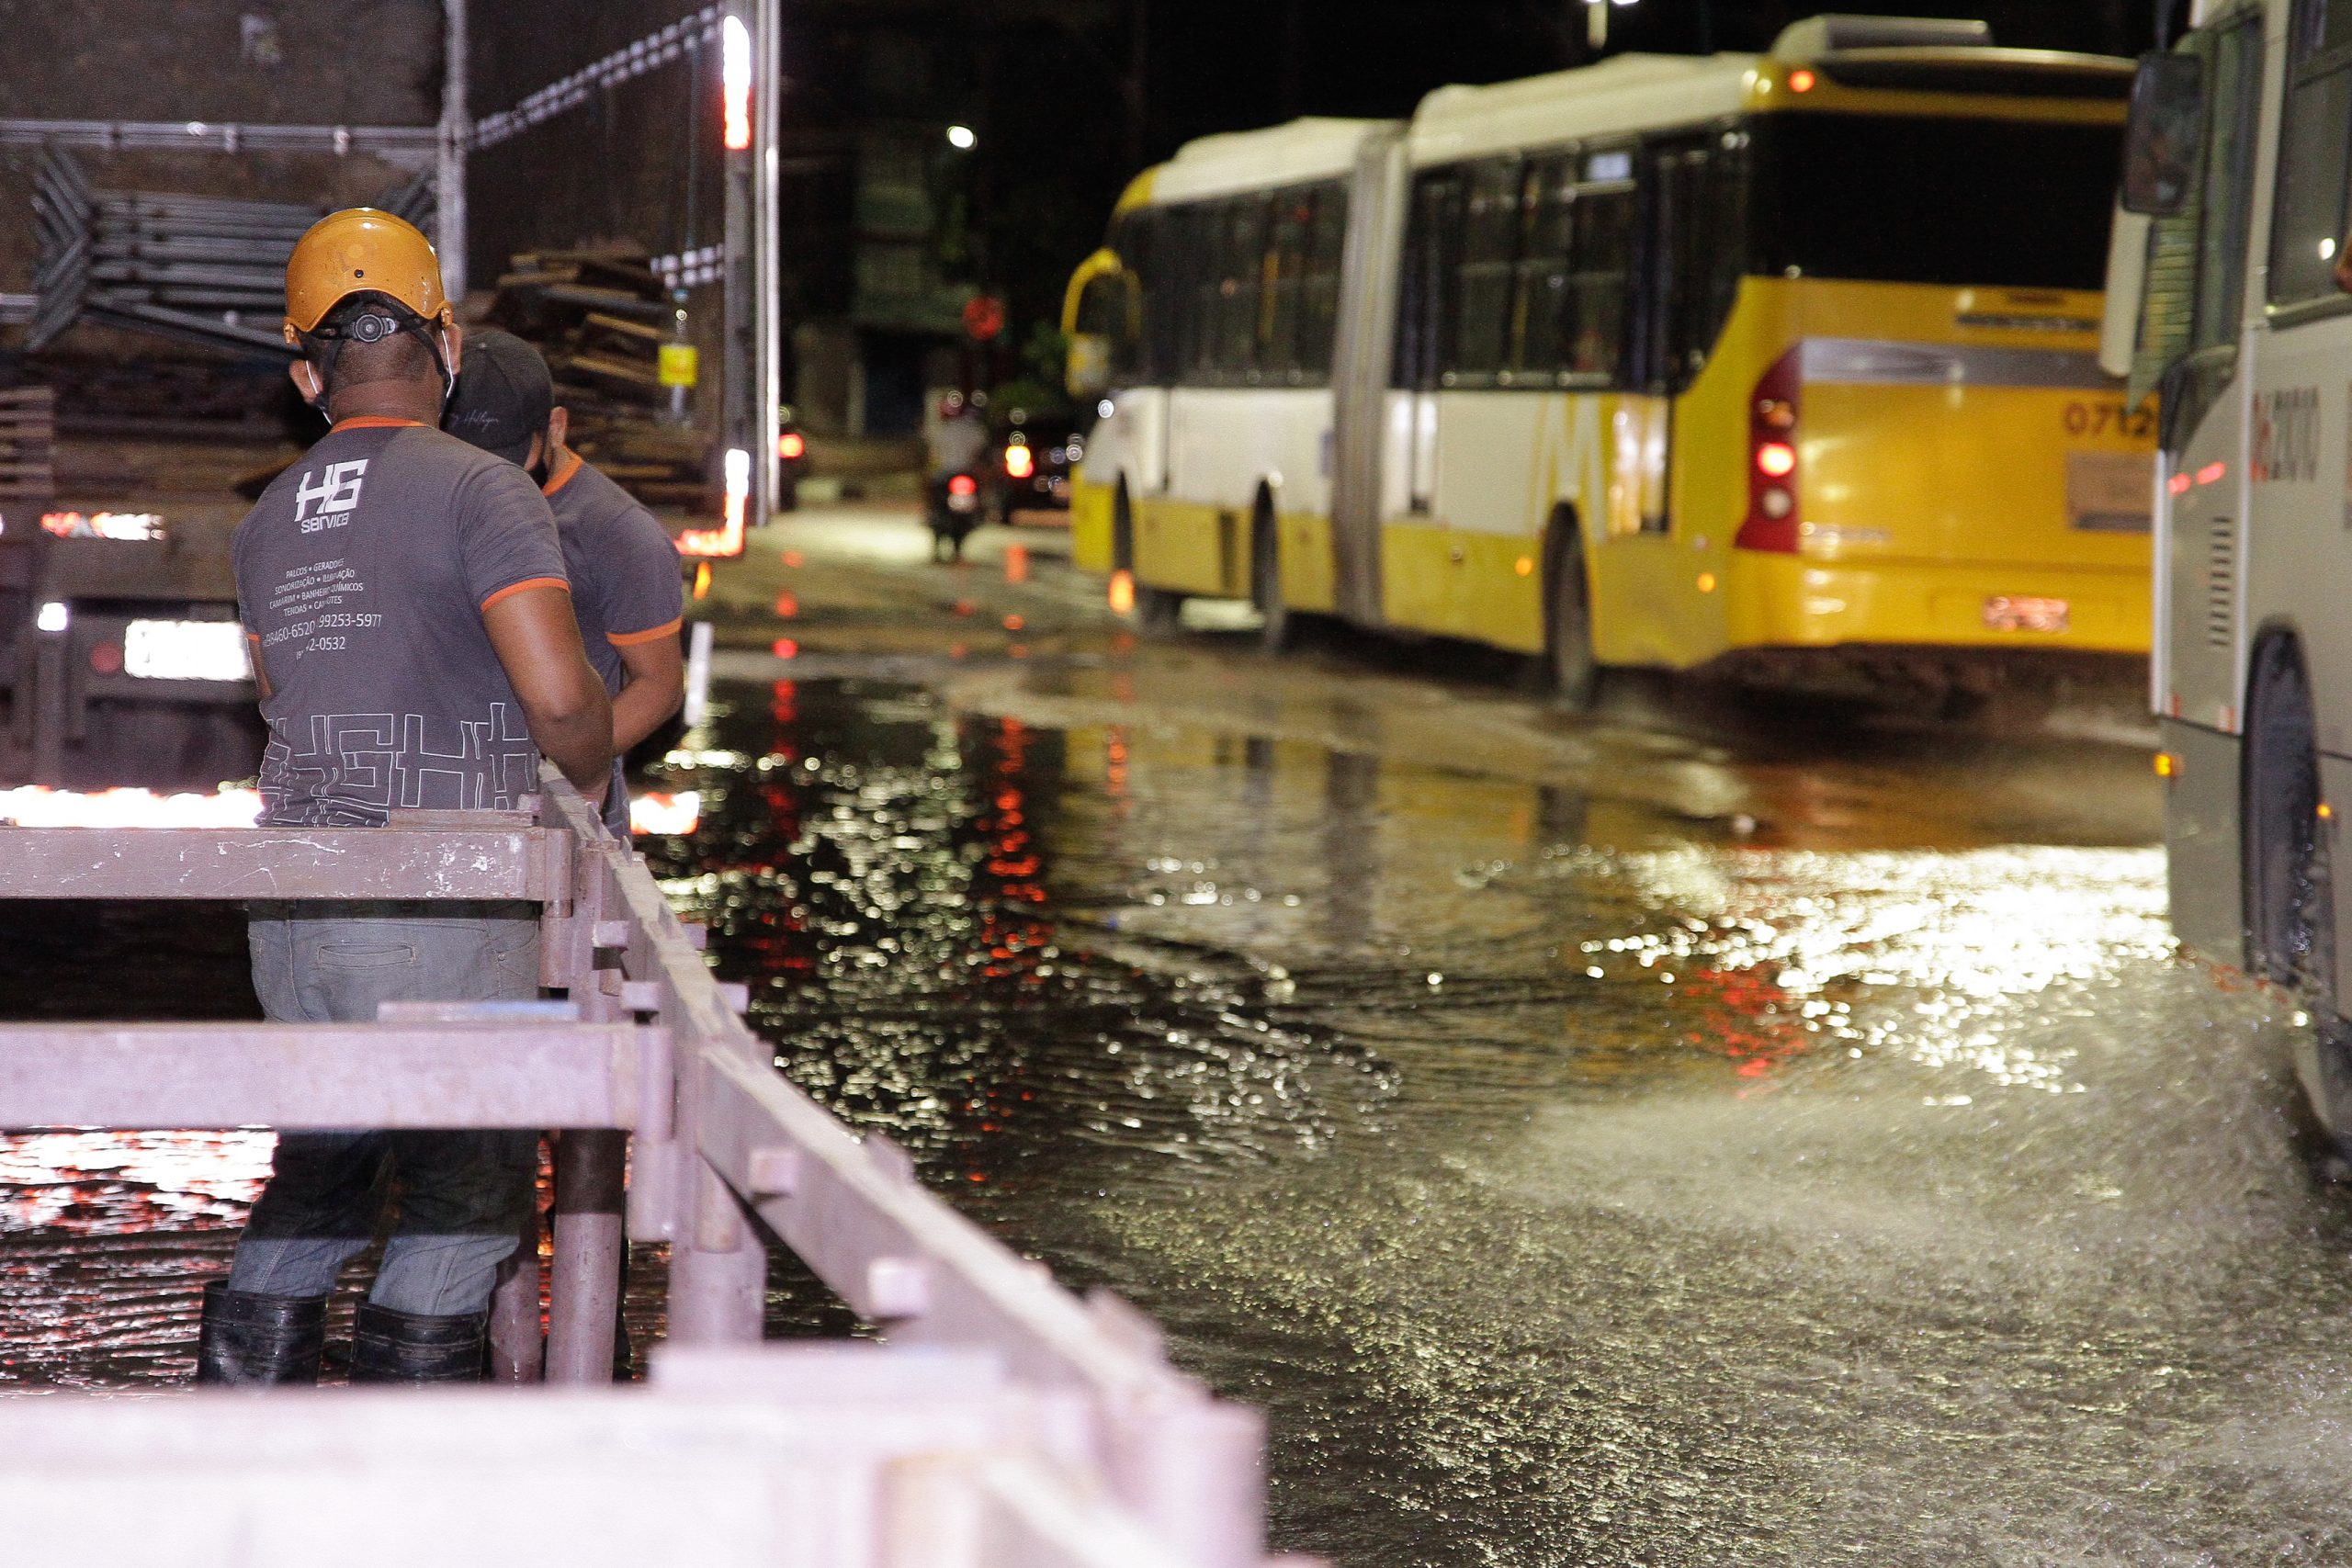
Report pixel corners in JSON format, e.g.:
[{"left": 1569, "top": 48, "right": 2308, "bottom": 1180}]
[{"left": 198, "top": 207, "right": 612, "bottom": 1384}]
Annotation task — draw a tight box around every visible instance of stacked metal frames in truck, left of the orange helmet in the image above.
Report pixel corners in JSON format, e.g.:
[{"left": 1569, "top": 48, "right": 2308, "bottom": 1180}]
[{"left": 26, "top": 146, "right": 433, "bottom": 353}]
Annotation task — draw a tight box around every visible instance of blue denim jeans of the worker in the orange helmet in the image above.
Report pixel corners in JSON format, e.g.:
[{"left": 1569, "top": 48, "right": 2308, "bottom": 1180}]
[{"left": 228, "top": 903, "right": 538, "bottom": 1316}]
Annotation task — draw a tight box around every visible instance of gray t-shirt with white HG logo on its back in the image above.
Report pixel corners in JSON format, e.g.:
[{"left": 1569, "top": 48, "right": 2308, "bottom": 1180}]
[{"left": 235, "top": 419, "right": 567, "bottom": 828}]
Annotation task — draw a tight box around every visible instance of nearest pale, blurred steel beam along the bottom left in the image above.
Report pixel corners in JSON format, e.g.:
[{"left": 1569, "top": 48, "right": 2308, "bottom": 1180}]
[{"left": 0, "top": 1345, "right": 1204, "bottom": 1568}]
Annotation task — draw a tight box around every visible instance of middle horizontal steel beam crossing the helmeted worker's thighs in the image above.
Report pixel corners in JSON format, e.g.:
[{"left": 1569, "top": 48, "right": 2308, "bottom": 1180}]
[{"left": 0, "top": 1022, "right": 639, "bottom": 1128}]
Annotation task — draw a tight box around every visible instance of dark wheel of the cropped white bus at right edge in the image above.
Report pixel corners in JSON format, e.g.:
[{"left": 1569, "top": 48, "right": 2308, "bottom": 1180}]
[{"left": 2244, "top": 637, "right": 2335, "bottom": 1016}]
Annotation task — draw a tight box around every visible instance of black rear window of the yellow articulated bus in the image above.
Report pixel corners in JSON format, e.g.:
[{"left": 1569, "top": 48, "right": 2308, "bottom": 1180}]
[{"left": 1750, "top": 113, "right": 2124, "bottom": 289}]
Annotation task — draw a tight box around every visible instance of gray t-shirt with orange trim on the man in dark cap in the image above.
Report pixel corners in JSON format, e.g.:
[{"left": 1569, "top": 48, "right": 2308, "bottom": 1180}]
[{"left": 548, "top": 451, "right": 687, "bottom": 844}]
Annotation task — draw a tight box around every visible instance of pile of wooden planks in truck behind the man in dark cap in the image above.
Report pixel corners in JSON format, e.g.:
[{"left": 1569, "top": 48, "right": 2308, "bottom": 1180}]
[{"left": 475, "top": 252, "right": 713, "bottom": 505}]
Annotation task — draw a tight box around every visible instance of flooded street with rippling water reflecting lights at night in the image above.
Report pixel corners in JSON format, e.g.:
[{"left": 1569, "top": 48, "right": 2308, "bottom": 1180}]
[{"left": 0, "top": 514, "right": 2352, "bottom": 1568}]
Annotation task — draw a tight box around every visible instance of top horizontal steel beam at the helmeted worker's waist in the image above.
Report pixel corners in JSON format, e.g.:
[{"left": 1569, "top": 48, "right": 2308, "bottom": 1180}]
[{"left": 0, "top": 828, "right": 571, "bottom": 903}]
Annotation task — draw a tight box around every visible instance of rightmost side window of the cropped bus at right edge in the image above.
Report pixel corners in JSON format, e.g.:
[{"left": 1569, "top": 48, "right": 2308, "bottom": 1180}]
[{"left": 2269, "top": 0, "right": 2352, "bottom": 303}]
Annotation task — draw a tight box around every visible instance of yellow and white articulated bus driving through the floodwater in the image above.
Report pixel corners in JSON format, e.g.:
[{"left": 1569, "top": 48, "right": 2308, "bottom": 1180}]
[{"left": 1063, "top": 17, "right": 2154, "bottom": 701}]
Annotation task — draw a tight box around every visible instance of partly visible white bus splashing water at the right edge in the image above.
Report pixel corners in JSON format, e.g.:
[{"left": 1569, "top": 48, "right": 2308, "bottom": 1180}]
[{"left": 2112, "top": 0, "right": 2352, "bottom": 1131}]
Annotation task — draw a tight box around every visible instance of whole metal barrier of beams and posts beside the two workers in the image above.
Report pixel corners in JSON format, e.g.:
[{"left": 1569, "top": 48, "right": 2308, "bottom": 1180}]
[{"left": 0, "top": 771, "right": 1265, "bottom": 1568}]
